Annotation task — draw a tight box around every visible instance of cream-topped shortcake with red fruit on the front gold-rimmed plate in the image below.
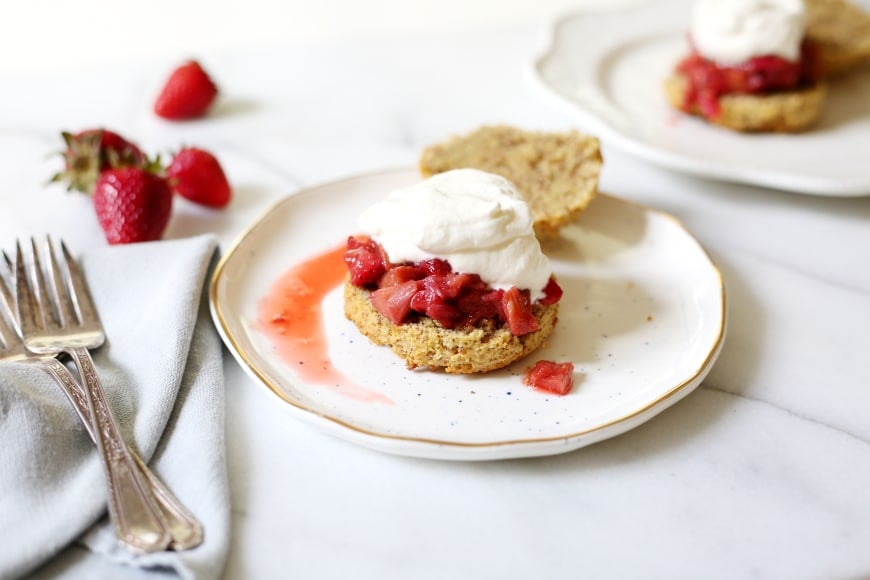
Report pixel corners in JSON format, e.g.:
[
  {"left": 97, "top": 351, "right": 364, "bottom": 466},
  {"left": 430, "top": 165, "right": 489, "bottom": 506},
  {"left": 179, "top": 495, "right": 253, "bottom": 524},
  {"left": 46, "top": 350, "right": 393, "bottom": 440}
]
[{"left": 344, "top": 168, "right": 562, "bottom": 373}]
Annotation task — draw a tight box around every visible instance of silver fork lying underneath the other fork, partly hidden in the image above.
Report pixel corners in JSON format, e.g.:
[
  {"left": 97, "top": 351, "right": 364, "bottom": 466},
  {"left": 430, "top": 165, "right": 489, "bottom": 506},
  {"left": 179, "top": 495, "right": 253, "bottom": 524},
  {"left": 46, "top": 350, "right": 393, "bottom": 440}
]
[{"left": 0, "top": 247, "right": 203, "bottom": 550}]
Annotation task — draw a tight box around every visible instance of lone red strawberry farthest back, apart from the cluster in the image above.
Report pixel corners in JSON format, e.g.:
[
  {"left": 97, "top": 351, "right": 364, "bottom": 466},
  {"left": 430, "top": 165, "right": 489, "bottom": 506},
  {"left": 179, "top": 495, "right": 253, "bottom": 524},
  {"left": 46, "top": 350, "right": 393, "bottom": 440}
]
[{"left": 154, "top": 60, "right": 218, "bottom": 121}]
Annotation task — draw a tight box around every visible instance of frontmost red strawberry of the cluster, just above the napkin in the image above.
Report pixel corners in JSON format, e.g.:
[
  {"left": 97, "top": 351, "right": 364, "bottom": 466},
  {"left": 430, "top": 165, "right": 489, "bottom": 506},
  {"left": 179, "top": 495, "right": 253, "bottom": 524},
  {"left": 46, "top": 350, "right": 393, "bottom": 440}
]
[{"left": 94, "top": 167, "right": 172, "bottom": 244}]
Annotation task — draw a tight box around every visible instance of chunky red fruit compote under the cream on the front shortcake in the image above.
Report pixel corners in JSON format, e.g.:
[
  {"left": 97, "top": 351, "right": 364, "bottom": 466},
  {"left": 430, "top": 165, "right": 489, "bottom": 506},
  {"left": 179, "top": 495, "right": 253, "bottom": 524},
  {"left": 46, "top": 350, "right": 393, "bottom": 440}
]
[{"left": 344, "top": 236, "right": 562, "bottom": 336}]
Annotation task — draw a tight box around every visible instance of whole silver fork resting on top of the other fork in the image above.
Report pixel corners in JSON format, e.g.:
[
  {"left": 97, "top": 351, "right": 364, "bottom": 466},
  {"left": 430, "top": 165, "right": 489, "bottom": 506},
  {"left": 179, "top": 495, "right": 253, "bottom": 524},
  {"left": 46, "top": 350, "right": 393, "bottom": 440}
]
[{"left": 15, "top": 239, "right": 205, "bottom": 552}]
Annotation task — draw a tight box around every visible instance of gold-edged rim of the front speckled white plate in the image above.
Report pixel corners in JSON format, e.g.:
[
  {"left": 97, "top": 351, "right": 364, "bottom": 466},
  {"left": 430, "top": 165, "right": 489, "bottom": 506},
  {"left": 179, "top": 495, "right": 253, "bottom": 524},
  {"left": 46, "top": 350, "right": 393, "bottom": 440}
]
[{"left": 208, "top": 167, "right": 727, "bottom": 460}]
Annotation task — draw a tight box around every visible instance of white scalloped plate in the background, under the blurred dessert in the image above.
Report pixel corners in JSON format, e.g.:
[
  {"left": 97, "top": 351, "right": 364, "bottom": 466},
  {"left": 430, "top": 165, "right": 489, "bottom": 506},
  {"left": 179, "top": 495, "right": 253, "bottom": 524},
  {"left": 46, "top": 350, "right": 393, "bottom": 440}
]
[{"left": 530, "top": 0, "right": 870, "bottom": 196}]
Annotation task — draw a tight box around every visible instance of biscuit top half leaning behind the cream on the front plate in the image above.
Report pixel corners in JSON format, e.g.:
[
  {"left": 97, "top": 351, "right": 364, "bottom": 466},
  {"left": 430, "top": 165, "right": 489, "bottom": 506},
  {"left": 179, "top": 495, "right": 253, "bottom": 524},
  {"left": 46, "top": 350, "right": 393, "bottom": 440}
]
[{"left": 420, "top": 125, "right": 602, "bottom": 237}]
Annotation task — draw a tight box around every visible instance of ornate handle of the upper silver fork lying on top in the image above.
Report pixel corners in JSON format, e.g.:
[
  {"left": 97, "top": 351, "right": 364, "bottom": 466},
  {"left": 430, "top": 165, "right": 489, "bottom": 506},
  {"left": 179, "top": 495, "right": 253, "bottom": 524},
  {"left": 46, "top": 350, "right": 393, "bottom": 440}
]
[{"left": 67, "top": 347, "right": 172, "bottom": 552}]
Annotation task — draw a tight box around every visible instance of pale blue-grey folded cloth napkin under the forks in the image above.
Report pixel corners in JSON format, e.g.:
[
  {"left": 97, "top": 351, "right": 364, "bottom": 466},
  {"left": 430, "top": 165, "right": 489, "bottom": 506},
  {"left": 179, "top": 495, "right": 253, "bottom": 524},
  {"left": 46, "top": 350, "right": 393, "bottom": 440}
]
[{"left": 0, "top": 236, "right": 230, "bottom": 579}]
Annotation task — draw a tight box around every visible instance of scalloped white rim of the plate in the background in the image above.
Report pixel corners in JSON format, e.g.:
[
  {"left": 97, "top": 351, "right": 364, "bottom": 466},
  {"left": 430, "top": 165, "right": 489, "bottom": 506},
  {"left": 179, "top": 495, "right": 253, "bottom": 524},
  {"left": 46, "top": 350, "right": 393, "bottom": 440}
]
[{"left": 524, "top": 0, "right": 870, "bottom": 198}]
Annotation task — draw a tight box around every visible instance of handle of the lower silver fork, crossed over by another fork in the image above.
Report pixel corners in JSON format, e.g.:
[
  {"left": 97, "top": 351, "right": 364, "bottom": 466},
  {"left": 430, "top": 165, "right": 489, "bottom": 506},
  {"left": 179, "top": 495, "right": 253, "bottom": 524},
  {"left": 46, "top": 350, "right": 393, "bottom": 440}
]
[{"left": 39, "top": 358, "right": 204, "bottom": 550}]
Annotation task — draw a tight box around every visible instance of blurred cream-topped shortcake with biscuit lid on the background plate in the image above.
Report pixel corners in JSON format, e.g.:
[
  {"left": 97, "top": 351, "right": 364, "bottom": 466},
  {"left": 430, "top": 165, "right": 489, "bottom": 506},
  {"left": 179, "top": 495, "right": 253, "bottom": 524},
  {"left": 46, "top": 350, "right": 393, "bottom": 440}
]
[{"left": 665, "top": 0, "right": 870, "bottom": 133}]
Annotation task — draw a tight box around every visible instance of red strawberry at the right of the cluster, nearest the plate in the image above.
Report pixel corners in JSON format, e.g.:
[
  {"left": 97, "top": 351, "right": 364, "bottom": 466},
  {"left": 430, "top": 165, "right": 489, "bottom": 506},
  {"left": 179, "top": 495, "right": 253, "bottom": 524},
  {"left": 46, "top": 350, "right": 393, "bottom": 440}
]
[{"left": 166, "top": 147, "right": 232, "bottom": 207}]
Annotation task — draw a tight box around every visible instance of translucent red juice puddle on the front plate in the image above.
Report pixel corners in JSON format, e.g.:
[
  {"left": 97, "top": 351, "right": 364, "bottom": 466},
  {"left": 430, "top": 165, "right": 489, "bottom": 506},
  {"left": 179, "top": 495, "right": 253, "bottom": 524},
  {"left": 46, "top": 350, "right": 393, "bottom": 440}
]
[{"left": 255, "top": 244, "right": 393, "bottom": 403}]
